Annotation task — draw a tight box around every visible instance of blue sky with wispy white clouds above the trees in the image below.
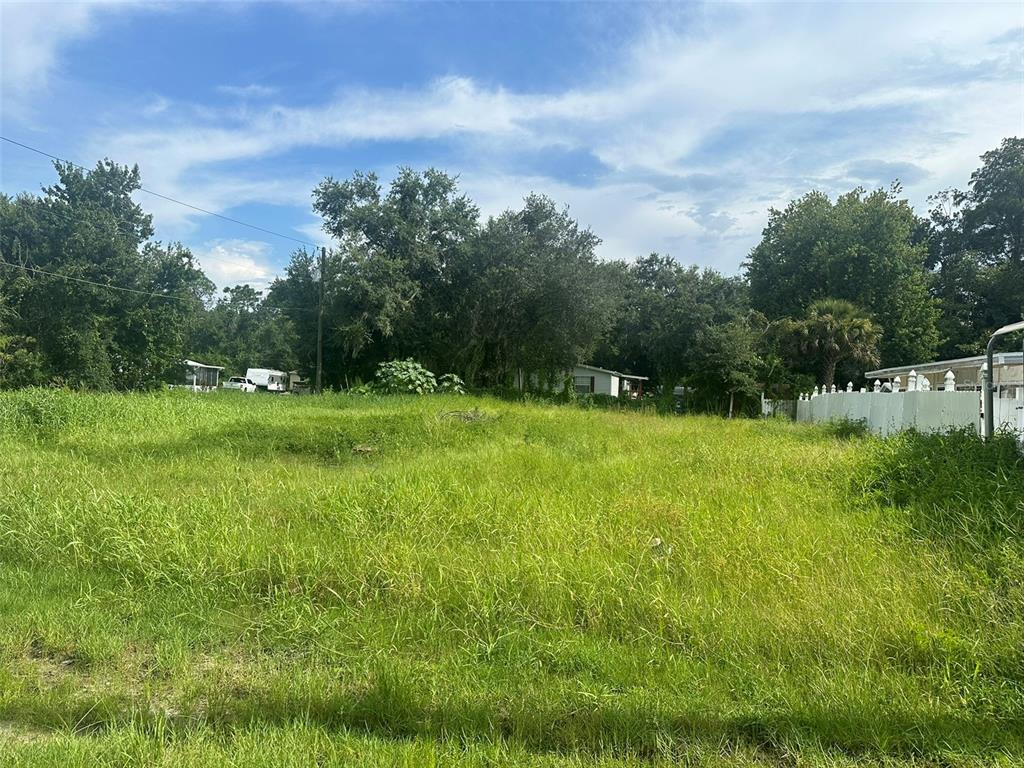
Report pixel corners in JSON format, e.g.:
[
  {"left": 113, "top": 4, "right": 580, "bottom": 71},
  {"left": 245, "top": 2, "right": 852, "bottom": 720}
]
[{"left": 0, "top": 1, "right": 1024, "bottom": 287}]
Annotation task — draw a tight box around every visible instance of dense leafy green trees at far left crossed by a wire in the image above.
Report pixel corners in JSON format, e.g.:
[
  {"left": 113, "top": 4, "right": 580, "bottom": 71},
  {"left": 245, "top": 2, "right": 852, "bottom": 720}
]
[{"left": 0, "top": 161, "right": 212, "bottom": 389}]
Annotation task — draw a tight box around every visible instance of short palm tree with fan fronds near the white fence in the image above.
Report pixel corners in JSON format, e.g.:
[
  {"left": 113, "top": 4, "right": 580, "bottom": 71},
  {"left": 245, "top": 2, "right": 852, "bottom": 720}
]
[{"left": 790, "top": 299, "right": 882, "bottom": 389}]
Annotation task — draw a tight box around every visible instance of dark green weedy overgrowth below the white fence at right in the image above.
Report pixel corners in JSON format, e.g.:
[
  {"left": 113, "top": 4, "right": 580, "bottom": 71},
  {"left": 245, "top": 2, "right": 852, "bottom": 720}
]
[{"left": 857, "top": 430, "right": 1024, "bottom": 671}]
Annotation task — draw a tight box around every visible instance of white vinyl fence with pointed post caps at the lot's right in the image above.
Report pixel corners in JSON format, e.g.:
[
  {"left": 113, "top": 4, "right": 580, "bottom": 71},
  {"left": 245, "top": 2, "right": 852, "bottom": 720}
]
[{"left": 797, "top": 371, "right": 1024, "bottom": 435}]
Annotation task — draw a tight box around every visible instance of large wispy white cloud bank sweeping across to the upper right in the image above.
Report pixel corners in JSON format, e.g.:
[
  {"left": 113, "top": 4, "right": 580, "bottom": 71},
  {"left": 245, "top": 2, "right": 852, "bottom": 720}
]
[{"left": 39, "top": 3, "right": 1024, "bottom": 270}]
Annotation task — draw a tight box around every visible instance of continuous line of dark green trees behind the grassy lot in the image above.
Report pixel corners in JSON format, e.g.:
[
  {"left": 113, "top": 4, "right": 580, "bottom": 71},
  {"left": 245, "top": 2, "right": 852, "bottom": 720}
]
[{"left": 0, "top": 138, "right": 1024, "bottom": 411}]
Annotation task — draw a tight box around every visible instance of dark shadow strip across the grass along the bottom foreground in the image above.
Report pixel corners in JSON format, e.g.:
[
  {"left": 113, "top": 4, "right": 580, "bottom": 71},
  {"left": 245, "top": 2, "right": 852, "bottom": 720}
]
[{"left": 0, "top": 680, "right": 1024, "bottom": 766}]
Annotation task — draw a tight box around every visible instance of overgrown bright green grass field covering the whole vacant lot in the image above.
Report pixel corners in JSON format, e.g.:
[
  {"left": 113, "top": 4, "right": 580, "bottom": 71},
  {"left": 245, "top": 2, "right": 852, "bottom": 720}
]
[{"left": 0, "top": 390, "right": 1024, "bottom": 766}]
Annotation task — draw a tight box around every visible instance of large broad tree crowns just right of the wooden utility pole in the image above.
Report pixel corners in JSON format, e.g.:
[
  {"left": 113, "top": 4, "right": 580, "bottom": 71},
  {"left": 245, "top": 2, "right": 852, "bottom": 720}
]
[{"left": 299, "top": 175, "right": 613, "bottom": 387}]
